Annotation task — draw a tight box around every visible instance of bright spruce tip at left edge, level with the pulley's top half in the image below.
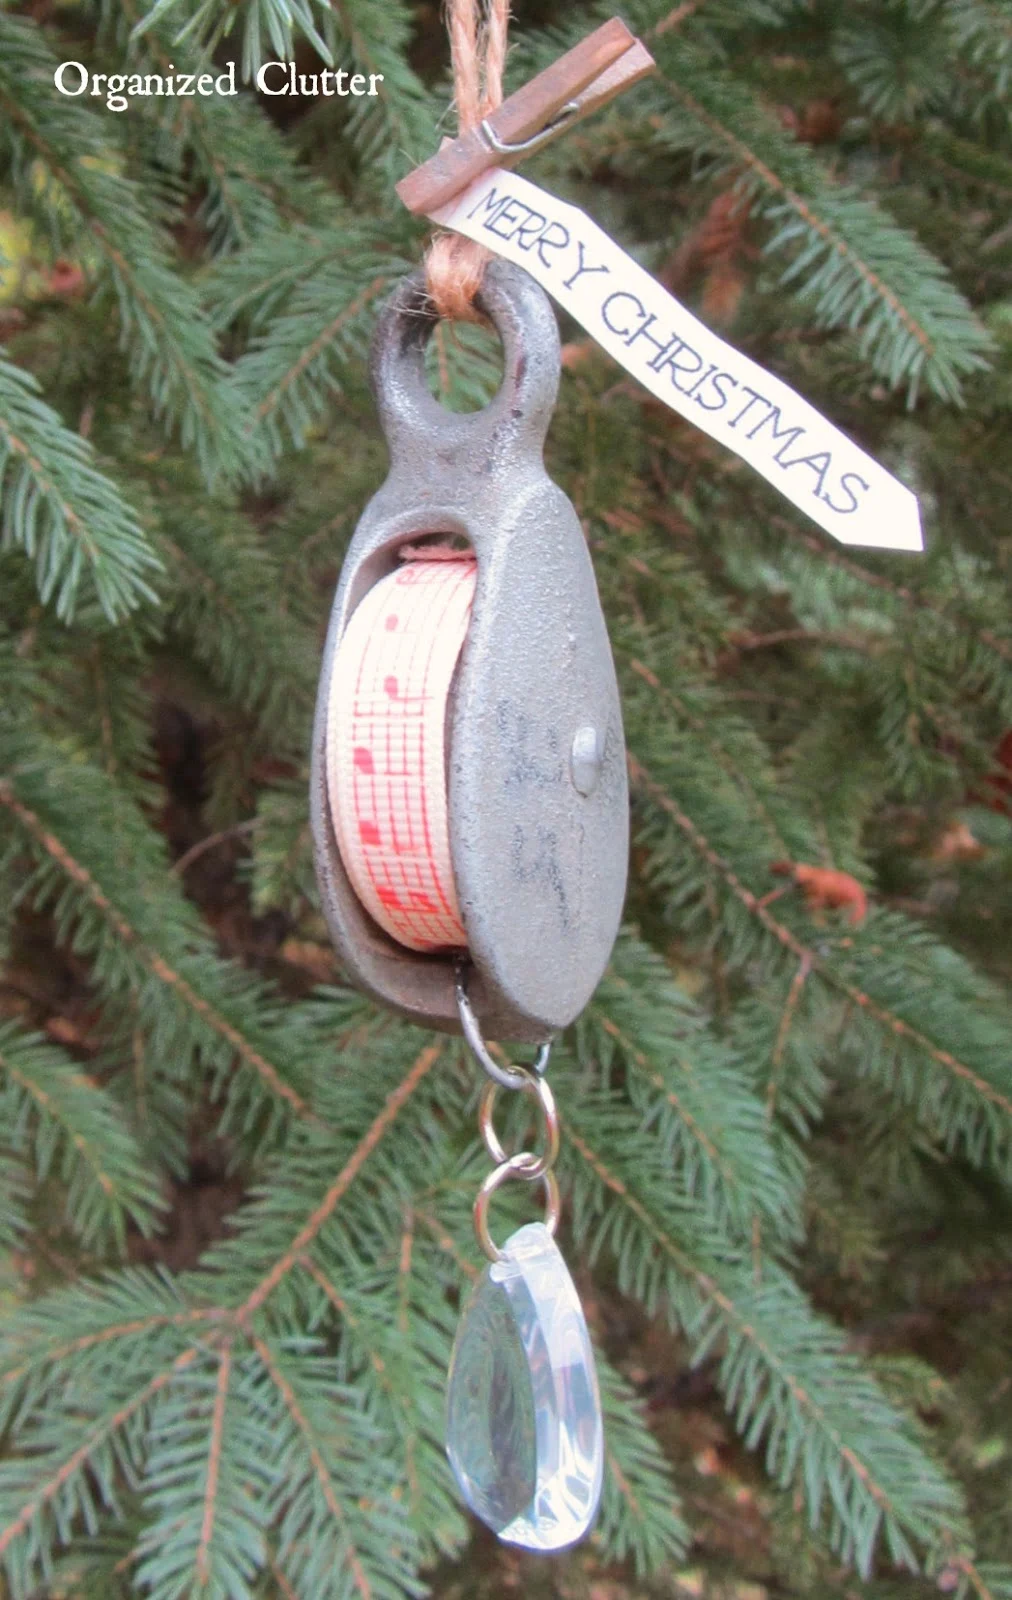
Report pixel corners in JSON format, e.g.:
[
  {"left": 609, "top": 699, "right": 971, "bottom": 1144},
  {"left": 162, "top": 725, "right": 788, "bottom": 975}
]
[{"left": 0, "top": 354, "right": 160, "bottom": 621}]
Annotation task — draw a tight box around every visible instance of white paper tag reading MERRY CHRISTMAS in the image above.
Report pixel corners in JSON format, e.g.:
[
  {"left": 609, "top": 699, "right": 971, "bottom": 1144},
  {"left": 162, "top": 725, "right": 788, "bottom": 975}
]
[{"left": 432, "top": 168, "right": 922, "bottom": 550}]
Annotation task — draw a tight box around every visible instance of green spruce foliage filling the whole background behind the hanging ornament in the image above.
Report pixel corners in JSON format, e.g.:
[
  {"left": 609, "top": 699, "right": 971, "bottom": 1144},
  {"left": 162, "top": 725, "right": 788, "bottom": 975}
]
[{"left": 0, "top": 0, "right": 1012, "bottom": 1600}]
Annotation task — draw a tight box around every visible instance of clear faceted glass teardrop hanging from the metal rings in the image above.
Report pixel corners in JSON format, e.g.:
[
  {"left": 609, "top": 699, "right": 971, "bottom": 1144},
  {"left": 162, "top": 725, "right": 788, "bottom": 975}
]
[{"left": 447, "top": 1222, "right": 604, "bottom": 1550}]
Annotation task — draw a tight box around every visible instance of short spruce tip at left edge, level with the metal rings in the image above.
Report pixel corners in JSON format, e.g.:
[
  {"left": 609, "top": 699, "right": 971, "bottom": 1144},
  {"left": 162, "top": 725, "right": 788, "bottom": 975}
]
[{"left": 0, "top": 1022, "right": 162, "bottom": 1250}]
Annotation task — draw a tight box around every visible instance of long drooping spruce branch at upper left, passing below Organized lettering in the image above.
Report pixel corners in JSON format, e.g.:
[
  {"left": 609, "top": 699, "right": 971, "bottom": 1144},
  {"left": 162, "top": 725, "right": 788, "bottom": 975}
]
[{"left": 0, "top": 14, "right": 243, "bottom": 478}]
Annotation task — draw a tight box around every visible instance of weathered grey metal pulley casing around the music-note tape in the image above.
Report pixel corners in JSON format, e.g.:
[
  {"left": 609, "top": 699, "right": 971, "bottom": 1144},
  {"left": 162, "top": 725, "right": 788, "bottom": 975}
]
[{"left": 311, "top": 261, "right": 628, "bottom": 1042}]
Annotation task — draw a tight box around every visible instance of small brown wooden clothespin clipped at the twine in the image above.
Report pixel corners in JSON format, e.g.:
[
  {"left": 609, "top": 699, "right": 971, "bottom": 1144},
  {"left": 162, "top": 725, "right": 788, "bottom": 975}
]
[{"left": 397, "top": 16, "right": 657, "bottom": 216}]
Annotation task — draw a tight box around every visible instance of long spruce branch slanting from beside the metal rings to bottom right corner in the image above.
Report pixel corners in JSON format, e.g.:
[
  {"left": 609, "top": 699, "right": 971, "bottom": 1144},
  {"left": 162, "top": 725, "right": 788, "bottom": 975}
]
[{"left": 568, "top": 1106, "right": 962, "bottom": 1574}]
